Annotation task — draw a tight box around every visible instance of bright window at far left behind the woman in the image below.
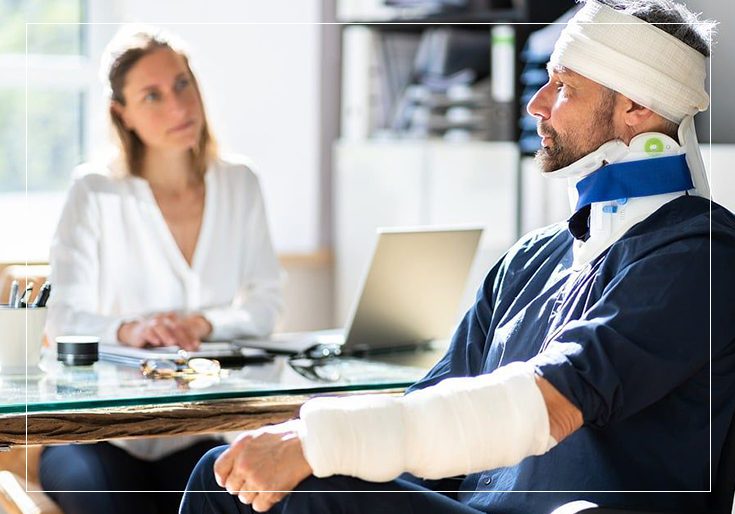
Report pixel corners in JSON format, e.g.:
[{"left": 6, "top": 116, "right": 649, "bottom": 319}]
[{"left": 0, "top": 0, "right": 91, "bottom": 262}]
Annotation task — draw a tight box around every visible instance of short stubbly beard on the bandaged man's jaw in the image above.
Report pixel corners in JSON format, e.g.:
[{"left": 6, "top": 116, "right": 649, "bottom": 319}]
[{"left": 536, "top": 93, "right": 615, "bottom": 173}]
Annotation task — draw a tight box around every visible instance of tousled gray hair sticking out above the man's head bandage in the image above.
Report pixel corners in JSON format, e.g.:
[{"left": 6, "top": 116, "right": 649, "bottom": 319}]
[{"left": 583, "top": 0, "right": 716, "bottom": 57}]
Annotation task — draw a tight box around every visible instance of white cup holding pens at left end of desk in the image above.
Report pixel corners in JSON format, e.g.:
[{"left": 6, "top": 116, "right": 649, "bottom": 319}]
[{"left": 0, "top": 306, "right": 47, "bottom": 375}]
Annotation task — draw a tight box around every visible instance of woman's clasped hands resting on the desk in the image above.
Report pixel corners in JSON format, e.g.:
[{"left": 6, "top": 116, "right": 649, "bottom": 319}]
[{"left": 117, "top": 312, "right": 212, "bottom": 351}]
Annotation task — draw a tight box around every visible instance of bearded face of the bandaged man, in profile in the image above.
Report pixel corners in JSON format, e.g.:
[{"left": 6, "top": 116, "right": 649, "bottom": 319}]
[{"left": 527, "top": 67, "right": 617, "bottom": 172}]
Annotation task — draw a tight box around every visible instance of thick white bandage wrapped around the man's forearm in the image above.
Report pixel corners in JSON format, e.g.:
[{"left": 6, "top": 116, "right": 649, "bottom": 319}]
[{"left": 299, "top": 362, "right": 555, "bottom": 482}]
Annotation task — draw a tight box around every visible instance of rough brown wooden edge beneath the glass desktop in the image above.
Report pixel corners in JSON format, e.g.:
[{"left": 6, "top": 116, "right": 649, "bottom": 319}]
[{"left": 0, "top": 389, "right": 403, "bottom": 447}]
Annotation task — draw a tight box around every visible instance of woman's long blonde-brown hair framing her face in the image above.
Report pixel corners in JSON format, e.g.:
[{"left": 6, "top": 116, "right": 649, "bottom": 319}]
[{"left": 101, "top": 25, "right": 217, "bottom": 177}]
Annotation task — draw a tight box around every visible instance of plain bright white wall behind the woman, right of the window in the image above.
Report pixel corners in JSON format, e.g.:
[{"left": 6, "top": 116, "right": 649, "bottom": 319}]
[{"left": 90, "top": 0, "right": 323, "bottom": 253}]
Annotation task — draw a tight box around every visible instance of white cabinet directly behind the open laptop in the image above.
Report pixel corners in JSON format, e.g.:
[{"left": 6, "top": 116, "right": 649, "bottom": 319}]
[{"left": 333, "top": 140, "right": 519, "bottom": 325}]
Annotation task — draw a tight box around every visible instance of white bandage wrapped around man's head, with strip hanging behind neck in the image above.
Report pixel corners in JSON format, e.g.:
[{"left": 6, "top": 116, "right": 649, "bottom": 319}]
[{"left": 550, "top": 0, "right": 709, "bottom": 196}]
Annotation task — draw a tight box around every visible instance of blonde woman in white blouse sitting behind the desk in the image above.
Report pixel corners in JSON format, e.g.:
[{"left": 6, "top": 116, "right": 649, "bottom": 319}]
[{"left": 41, "top": 27, "right": 281, "bottom": 514}]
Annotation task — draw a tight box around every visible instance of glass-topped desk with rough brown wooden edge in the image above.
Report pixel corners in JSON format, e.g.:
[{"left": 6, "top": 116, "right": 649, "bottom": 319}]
[{"left": 0, "top": 347, "right": 444, "bottom": 446}]
